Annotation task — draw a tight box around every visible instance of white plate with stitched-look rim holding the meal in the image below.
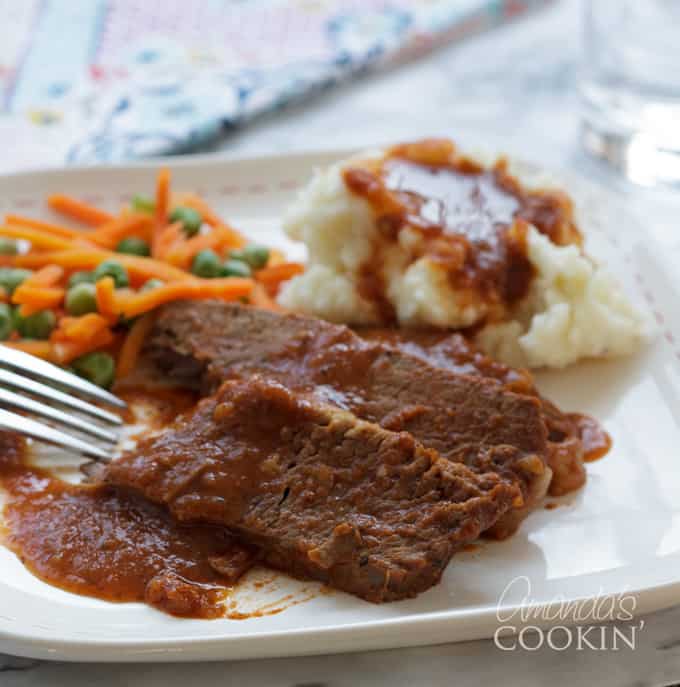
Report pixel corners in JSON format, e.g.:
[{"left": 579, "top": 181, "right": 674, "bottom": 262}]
[{"left": 0, "top": 151, "right": 680, "bottom": 661}]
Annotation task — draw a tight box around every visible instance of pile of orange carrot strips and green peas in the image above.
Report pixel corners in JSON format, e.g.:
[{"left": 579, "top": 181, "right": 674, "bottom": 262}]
[{"left": 0, "top": 169, "right": 303, "bottom": 387}]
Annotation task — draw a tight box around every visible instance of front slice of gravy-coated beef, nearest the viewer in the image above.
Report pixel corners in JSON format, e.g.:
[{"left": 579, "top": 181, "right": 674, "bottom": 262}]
[{"left": 100, "top": 378, "right": 519, "bottom": 602}]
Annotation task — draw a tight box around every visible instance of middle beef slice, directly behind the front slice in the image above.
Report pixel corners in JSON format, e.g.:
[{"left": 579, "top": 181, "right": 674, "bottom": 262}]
[{"left": 148, "top": 301, "right": 550, "bottom": 537}]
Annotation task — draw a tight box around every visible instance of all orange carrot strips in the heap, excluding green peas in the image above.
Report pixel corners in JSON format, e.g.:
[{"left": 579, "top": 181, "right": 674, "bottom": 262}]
[{"left": 11, "top": 168, "right": 284, "bottom": 384}]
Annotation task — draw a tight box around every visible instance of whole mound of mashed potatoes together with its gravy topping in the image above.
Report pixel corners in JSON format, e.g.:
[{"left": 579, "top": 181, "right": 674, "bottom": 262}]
[{"left": 279, "top": 140, "right": 648, "bottom": 367}]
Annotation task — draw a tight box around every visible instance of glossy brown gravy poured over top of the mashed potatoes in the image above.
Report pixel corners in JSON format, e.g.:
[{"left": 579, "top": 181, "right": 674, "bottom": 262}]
[{"left": 343, "top": 140, "right": 581, "bottom": 322}]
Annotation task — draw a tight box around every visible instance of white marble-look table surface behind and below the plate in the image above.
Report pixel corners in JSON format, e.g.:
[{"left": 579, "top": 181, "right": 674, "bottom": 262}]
[{"left": 0, "top": 0, "right": 680, "bottom": 687}]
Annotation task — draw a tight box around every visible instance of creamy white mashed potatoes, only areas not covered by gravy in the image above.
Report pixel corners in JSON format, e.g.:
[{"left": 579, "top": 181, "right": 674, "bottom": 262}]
[{"left": 279, "top": 147, "right": 650, "bottom": 367}]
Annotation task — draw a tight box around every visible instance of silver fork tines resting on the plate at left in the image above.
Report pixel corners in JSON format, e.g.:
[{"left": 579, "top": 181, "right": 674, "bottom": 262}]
[{"left": 0, "top": 345, "right": 126, "bottom": 462}]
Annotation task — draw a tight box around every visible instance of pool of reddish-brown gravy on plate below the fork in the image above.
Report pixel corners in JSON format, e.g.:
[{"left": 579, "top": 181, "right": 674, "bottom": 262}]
[{"left": 0, "top": 389, "right": 254, "bottom": 618}]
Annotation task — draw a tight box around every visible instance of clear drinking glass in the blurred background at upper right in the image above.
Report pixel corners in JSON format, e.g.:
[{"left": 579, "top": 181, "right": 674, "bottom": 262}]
[{"left": 580, "top": 0, "right": 680, "bottom": 188}]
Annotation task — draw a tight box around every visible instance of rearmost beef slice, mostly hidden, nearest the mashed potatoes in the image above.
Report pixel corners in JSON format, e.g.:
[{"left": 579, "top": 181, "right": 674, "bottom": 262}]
[{"left": 357, "top": 328, "right": 588, "bottom": 496}]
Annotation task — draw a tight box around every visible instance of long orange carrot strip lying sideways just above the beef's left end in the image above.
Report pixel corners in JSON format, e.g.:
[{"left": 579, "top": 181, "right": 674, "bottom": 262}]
[{"left": 116, "top": 277, "right": 253, "bottom": 317}]
